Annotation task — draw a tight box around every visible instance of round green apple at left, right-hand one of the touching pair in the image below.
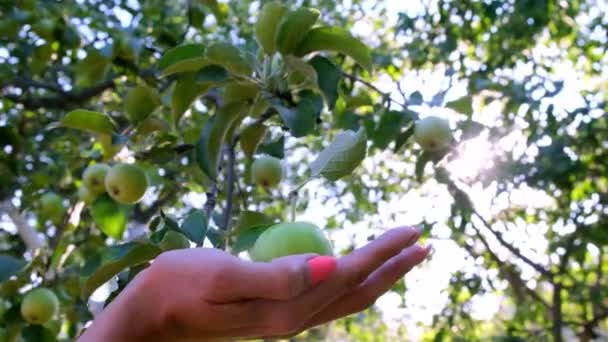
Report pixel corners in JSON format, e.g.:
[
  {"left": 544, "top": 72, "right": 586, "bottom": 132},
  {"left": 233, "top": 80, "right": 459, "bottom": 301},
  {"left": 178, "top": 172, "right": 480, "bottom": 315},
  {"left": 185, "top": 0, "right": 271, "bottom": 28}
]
[{"left": 105, "top": 164, "right": 148, "bottom": 204}]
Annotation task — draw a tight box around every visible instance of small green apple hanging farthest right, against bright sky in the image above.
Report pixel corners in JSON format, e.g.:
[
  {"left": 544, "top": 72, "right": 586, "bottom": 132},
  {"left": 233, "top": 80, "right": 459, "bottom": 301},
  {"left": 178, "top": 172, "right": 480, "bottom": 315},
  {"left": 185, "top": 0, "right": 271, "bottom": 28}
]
[{"left": 414, "top": 116, "right": 453, "bottom": 152}]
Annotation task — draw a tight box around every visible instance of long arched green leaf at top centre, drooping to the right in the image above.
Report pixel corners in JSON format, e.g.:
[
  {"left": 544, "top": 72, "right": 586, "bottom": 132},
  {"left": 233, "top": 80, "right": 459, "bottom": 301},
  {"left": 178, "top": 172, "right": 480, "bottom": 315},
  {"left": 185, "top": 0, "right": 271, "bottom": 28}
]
[{"left": 295, "top": 26, "right": 372, "bottom": 70}]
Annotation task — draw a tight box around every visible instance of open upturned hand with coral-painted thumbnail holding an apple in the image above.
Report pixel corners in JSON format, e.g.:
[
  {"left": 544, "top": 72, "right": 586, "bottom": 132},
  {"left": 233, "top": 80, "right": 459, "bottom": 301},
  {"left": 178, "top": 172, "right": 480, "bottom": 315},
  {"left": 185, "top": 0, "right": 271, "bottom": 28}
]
[{"left": 81, "top": 228, "right": 430, "bottom": 342}]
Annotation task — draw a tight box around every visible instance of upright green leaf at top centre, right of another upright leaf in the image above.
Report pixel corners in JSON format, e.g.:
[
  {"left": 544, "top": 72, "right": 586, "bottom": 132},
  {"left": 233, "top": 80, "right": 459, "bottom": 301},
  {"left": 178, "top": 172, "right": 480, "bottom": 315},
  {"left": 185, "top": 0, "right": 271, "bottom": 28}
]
[{"left": 276, "top": 7, "right": 321, "bottom": 55}]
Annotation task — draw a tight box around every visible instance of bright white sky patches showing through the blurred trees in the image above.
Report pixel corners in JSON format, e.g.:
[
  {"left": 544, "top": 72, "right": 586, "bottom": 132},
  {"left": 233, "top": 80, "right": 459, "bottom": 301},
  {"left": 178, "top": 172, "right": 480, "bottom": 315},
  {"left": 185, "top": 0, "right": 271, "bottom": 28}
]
[{"left": 0, "top": 0, "right": 606, "bottom": 340}]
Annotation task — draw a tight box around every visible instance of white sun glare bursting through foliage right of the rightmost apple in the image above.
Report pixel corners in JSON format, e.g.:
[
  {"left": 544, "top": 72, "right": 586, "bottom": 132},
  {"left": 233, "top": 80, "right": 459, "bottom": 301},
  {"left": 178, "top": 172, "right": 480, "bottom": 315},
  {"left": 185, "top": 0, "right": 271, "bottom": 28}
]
[{"left": 447, "top": 135, "right": 495, "bottom": 180}]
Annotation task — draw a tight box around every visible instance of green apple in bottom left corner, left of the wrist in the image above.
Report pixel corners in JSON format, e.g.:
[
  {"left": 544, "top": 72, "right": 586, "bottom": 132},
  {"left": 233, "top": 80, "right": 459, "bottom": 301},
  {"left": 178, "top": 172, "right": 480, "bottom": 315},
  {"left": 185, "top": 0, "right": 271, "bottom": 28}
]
[{"left": 21, "top": 287, "right": 59, "bottom": 324}]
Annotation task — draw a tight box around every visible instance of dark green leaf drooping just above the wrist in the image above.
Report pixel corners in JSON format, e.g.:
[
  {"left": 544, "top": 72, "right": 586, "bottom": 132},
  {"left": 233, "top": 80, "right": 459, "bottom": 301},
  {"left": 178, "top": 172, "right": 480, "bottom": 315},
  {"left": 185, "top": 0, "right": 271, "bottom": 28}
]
[{"left": 81, "top": 241, "right": 162, "bottom": 299}]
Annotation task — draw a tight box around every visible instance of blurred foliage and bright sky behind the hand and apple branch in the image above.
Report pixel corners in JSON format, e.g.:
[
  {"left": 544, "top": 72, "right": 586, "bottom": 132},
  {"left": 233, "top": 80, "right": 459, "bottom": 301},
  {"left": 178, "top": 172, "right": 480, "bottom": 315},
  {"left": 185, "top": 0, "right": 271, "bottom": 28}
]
[{"left": 0, "top": 0, "right": 608, "bottom": 341}]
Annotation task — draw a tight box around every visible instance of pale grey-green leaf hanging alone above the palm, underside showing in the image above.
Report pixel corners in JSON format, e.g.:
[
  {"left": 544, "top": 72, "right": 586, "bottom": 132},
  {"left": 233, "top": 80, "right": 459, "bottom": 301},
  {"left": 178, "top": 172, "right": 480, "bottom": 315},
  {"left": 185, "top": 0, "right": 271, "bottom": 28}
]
[{"left": 310, "top": 127, "right": 367, "bottom": 181}]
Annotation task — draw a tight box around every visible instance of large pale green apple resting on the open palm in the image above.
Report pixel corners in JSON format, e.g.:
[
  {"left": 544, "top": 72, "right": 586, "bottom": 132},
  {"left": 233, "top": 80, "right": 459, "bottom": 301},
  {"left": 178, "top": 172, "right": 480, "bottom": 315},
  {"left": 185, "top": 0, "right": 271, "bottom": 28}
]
[{"left": 249, "top": 222, "right": 333, "bottom": 262}]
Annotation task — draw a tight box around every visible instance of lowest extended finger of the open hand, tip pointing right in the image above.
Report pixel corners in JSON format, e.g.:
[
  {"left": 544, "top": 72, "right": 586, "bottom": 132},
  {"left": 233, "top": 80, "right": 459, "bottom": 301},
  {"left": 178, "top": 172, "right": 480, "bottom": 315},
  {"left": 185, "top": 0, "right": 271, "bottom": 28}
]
[{"left": 307, "top": 244, "right": 431, "bottom": 328}]
